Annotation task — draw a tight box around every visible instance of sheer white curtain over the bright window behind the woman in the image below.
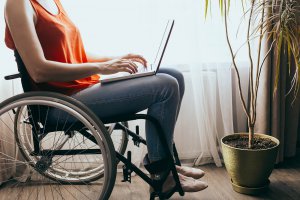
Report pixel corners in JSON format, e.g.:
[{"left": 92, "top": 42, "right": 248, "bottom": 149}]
[{"left": 62, "top": 0, "right": 248, "bottom": 166}]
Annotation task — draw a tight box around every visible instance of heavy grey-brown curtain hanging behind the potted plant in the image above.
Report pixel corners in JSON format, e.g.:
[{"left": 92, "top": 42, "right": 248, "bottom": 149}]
[{"left": 255, "top": 33, "right": 300, "bottom": 163}]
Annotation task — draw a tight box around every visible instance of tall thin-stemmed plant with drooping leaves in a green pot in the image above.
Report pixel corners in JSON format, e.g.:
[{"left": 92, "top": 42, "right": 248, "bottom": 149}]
[{"left": 205, "top": 0, "right": 300, "bottom": 194}]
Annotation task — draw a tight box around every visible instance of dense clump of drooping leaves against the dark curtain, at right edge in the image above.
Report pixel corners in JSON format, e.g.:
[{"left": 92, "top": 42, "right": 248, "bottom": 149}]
[{"left": 266, "top": 0, "right": 300, "bottom": 95}]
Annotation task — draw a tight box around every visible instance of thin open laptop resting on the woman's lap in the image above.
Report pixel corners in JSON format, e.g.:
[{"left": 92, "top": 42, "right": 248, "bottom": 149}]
[{"left": 100, "top": 20, "right": 174, "bottom": 84}]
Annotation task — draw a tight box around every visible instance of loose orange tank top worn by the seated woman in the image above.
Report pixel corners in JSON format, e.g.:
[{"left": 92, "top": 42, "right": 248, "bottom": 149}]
[{"left": 5, "top": 0, "right": 100, "bottom": 93}]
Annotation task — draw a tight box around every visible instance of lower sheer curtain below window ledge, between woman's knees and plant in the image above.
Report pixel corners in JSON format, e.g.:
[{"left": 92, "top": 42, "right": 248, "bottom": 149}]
[{"left": 175, "top": 62, "right": 249, "bottom": 166}]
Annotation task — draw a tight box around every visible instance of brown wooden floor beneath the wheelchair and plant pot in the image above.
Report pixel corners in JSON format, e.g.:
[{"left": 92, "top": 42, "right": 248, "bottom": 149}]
[{"left": 0, "top": 154, "right": 300, "bottom": 200}]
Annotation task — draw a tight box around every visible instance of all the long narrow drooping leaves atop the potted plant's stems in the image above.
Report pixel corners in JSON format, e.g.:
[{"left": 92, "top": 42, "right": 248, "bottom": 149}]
[{"left": 205, "top": 0, "right": 300, "bottom": 98}]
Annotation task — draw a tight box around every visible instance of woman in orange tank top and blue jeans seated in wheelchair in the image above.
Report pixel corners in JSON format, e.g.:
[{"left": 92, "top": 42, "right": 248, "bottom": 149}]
[{"left": 5, "top": 0, "right": 207, "bottom": 192}]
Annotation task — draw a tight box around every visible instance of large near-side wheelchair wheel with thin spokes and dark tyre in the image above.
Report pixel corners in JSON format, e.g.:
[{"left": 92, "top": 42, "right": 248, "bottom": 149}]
[{"left": 0, "top": 92, "right": 116, "bottom": 199}]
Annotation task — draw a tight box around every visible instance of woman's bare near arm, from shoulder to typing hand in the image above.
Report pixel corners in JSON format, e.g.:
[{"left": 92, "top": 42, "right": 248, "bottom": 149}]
[{"left": 5, "top": 0, "right": 137, "bottom": 83}]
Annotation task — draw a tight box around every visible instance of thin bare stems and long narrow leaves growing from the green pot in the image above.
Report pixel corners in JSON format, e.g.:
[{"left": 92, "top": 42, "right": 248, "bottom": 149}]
[{"left": 205, "top": 0, "right": 300, "bottom": 148}]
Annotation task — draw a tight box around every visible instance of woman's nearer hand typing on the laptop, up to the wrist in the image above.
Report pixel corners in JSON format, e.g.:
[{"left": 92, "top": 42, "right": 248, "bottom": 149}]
[{"left": 99, "top": 58, "right": 138, "bottom": 75}]
